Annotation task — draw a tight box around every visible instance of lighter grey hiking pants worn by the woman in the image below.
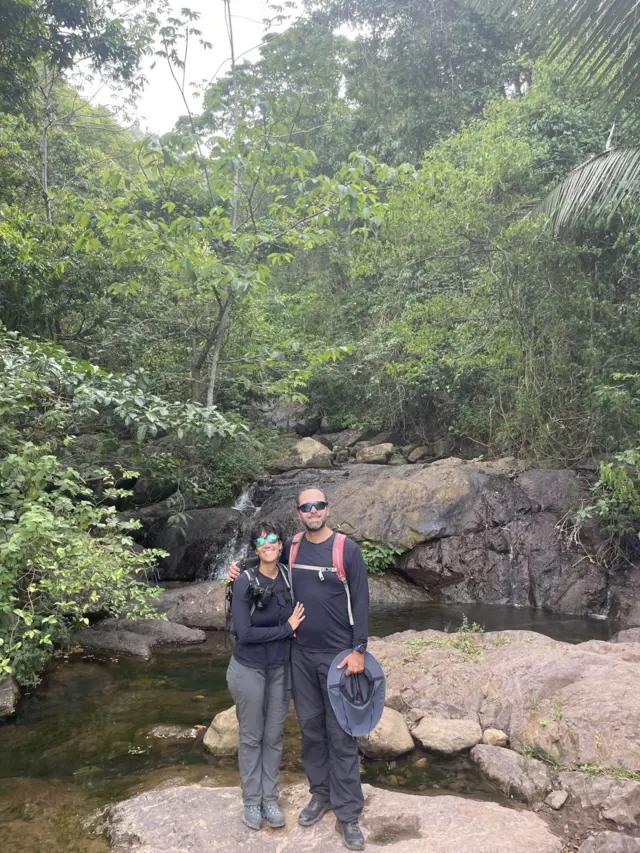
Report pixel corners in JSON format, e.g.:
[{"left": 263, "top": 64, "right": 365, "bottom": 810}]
[{"left": 227, "top": 657, "right": 289, "bottom": 806}]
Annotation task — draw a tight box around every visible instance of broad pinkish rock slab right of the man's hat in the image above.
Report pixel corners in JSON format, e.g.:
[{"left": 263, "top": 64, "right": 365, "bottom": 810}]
[{"left": 370, "top": 631, "right": 640, "bottom": 771}]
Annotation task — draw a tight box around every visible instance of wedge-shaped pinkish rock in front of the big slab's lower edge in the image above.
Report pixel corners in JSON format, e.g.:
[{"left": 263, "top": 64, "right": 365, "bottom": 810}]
[{"left": 471, "top": 743, "right": 553, "bottom": 804}]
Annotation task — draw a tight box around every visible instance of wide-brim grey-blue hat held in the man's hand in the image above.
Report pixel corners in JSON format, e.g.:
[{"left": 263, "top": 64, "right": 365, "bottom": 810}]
[{"left": 327, "top": 649, "right": 386, "bottom": 737}]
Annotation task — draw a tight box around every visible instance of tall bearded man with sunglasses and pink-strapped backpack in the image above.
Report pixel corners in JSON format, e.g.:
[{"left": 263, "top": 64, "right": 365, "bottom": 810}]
[{"left": 229, "top": 489, "right": 369, "bottom": 850}]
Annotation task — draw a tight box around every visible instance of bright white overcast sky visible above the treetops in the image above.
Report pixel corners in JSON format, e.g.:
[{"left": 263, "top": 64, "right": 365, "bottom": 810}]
[{"left": 137, "top": 0, "right": 302, "bottom": 133}]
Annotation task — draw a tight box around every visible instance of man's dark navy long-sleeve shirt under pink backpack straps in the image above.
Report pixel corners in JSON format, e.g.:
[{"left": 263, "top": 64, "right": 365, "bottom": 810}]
[{"left": 282, "top": 533, "right": 369, "bottom": 654}]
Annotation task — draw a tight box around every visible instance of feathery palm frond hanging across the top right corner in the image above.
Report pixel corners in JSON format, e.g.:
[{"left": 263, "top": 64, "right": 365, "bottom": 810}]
[{"left": 466, "top": 0, "right": 640, "bottom": 102}]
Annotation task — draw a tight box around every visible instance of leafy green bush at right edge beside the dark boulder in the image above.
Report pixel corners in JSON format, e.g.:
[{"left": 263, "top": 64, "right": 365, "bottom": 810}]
[{"left": 576, "top": 450, "right": 640, "bottom": 539}]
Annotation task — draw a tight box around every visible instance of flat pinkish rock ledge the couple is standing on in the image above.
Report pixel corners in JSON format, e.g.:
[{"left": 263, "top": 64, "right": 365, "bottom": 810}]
[{"left": 108, "top": 785, "right": 562, "bottom": 853}]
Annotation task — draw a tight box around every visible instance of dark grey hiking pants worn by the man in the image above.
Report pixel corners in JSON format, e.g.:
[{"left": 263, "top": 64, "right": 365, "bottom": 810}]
[{"left": 291, "top": 642, "right": 364, "bottom": 823}]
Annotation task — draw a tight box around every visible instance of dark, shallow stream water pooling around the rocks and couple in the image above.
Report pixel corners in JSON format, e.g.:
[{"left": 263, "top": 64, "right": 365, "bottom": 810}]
[{"left": 0, "top": 604, "right": 612, "bottom": 853}]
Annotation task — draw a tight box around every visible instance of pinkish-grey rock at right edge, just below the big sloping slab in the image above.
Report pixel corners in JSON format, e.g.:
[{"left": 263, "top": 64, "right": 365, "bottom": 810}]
[{"left": 560, "top": 770, "right": 640, "bottom": 826}]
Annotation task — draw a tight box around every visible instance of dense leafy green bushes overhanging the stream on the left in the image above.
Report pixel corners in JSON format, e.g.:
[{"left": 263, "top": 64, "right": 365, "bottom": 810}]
[{"left": 0, "top": 332, "right": 242, "bottom": 684}]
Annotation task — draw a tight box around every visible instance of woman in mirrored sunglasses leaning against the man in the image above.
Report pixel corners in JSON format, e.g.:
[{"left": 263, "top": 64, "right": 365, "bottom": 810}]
[{"left": 227, "top": 522, "right": 304, "bottom": 829}]
